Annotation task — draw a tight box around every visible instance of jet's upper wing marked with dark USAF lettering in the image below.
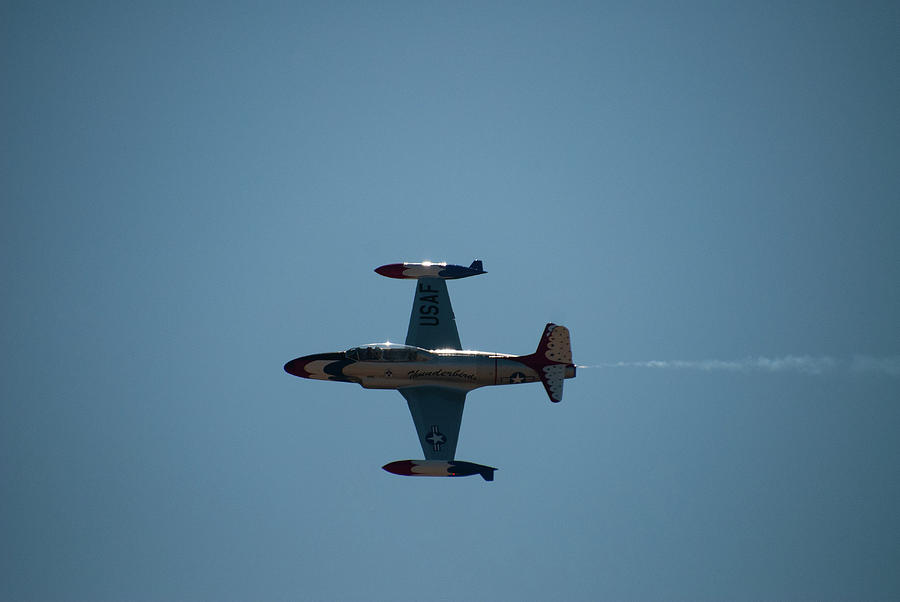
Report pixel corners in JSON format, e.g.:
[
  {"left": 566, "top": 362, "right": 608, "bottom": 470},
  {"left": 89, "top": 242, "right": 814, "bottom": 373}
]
[{"left": 406, "top": 278, "right": 462, "bottom": 349}]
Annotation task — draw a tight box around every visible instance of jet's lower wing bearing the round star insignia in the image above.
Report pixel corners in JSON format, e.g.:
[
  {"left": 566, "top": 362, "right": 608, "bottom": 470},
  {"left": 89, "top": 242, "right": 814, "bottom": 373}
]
[{"left": 398, "top": 387, "right": 466, "bottom": 460}]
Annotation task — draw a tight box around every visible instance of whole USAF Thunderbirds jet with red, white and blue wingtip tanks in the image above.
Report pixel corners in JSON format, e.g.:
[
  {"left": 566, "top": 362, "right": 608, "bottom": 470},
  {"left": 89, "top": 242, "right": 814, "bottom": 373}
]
[{"left": 284, "top": 260, "right": 575, "bottom": 481}]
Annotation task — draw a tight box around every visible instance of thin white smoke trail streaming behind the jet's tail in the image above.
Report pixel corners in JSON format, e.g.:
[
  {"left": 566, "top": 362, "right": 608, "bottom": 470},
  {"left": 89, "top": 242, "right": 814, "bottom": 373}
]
[{"left": 578, "top": 355, "right": 900, "bottom": 376}]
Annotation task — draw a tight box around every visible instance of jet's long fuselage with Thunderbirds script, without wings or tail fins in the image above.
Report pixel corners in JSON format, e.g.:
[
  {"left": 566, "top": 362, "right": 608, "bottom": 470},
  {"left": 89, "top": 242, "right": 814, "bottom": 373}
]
[{"left": 285, "top": 343, "right": 574, "bottom": 391}]
